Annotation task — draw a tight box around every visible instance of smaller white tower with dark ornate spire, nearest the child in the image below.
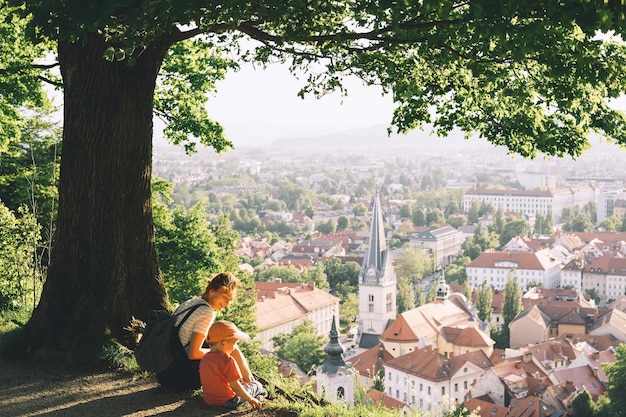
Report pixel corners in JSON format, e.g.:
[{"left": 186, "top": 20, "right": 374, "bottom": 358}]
[{"left": 315, "top": 316, "right": 356, "bottom": 405}]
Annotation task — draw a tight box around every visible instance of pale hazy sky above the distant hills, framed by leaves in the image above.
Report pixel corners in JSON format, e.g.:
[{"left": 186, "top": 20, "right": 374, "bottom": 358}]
[{"left": 208, "top": 61, "right": 392, "bottom": 145}]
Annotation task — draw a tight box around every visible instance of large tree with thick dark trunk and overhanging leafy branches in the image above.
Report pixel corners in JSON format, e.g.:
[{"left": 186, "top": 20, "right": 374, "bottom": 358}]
[{"left": 7, "top": 0, "right": 626, "bottom": 360}]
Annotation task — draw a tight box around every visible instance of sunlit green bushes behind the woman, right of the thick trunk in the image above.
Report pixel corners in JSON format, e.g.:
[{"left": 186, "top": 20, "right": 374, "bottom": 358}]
[{"left": 153, "top": 180, "right": 266, "bottom": 374}]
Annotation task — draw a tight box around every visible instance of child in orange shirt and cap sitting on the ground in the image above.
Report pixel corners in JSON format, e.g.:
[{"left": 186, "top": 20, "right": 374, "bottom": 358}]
[{"left": 200, "top": 320, "right": 267, "bottom": 410}]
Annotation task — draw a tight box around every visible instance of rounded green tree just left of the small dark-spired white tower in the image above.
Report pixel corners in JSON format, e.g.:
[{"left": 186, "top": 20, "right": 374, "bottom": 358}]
[{"left": 272, "top": 319, "right": 326, "bottom": 373}]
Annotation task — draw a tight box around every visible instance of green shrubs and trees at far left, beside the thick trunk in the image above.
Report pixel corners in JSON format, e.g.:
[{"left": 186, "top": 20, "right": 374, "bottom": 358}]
[{"left": 0, "top": 110, "right": 60, "bottom": 316}]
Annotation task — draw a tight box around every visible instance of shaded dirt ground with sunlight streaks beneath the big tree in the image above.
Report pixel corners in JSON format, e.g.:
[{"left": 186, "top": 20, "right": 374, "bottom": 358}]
[{"left": 0, "top": 356, "right": 290, "bottom": 417}]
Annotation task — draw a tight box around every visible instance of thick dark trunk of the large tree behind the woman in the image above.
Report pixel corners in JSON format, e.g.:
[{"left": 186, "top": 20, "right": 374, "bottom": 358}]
[{"left": 23, "top": 37, "right": 167, "bottom": 362}]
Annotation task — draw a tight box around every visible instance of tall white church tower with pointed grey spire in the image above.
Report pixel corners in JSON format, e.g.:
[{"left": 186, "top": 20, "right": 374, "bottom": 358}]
[{"left": 359, "top": 194, "right": 397, "bottom": 340}]
